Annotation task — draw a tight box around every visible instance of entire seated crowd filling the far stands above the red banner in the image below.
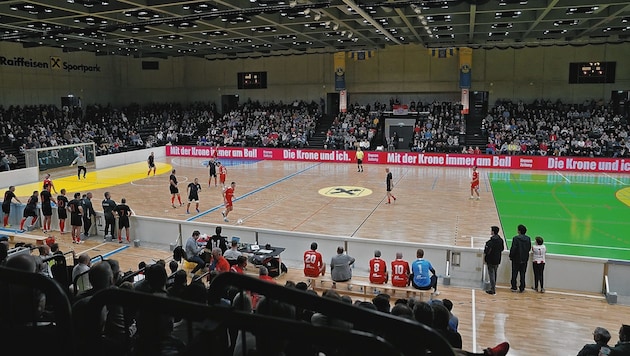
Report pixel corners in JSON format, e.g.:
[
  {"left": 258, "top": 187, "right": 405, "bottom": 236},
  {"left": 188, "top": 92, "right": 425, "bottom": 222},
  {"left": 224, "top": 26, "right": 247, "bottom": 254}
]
[{"left": 0, "top": 94, "right": 630, "bottom": 170}]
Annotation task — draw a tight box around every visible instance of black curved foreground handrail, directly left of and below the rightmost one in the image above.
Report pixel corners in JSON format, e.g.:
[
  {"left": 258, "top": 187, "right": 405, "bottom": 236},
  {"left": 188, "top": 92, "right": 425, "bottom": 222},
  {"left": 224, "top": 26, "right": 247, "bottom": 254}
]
[{"left": 81, "top": 288, "right": 404, "bottom": 356}]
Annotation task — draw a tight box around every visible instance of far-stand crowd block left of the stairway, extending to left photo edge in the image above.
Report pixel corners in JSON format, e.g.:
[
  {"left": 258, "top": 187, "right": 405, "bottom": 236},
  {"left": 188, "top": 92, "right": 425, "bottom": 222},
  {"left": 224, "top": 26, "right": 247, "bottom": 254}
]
[{"left": 0, "top": 101, "right": 321, "bottom": 169}]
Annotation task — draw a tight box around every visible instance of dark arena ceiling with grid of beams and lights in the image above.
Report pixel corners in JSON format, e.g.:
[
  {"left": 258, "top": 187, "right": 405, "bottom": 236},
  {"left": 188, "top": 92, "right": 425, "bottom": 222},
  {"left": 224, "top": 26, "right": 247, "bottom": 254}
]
[{"left": 0, "top": 0, "right": 630, "bottom": 60}]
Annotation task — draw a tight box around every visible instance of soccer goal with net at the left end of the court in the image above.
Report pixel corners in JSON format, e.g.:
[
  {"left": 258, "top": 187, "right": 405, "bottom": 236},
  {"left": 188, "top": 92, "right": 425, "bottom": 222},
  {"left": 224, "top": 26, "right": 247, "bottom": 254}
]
[{"left": 25, "top": 142, "right": 96, "bottom": 172}]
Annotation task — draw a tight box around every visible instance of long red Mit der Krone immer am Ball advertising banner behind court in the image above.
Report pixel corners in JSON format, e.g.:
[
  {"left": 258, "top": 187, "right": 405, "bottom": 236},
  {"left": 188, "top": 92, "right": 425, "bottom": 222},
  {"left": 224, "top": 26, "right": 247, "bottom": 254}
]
[{"left": 166, "top": 146, "right": 630, "bottom": 173}]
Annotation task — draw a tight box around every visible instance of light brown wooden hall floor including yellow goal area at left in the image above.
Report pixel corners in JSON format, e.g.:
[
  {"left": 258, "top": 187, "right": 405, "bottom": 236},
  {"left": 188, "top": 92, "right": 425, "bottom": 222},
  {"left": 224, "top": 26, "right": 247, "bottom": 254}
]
[{"left": 6, "top": 158, "right": 630, "bottom": 355}]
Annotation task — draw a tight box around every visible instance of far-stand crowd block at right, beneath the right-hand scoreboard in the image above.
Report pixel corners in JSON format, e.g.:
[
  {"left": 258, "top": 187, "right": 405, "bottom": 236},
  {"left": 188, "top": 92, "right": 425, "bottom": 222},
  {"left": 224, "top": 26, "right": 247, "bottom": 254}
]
[{"left": 482, "top": 100, "right": 630, "bottom": 157}]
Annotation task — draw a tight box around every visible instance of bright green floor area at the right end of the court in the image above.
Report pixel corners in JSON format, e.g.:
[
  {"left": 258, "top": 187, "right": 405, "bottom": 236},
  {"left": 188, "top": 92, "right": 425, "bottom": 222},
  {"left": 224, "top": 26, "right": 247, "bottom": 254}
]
[{"left": 488, "top": 172, "right": 630, "bottom": 261}]
